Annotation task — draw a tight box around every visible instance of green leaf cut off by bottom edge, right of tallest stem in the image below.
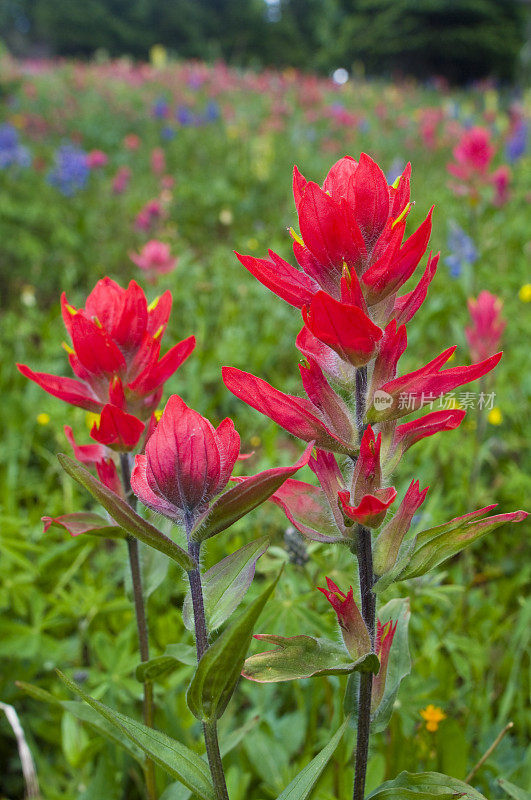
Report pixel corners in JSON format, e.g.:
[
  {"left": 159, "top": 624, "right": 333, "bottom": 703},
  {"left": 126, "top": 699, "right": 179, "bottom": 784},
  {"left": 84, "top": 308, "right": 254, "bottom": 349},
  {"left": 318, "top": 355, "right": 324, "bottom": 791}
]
[{"left": 366, "top": 772, "right": 486, "bottom": 800}]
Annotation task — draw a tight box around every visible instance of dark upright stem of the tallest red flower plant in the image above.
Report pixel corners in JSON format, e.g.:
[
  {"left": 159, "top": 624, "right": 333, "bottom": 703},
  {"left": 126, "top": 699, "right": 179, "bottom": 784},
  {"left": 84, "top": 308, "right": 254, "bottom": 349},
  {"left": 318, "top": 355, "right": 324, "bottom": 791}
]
[{"left": 353, "top": 367, "right": 376, "bottom": 800}]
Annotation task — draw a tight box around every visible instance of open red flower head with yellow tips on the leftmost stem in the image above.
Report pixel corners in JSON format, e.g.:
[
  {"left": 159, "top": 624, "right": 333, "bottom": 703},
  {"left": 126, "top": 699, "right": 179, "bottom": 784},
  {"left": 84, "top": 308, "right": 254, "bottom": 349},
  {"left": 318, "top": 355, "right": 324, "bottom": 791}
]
[{"left": 17, "top": 278, "right": 195, "bottom": 420}]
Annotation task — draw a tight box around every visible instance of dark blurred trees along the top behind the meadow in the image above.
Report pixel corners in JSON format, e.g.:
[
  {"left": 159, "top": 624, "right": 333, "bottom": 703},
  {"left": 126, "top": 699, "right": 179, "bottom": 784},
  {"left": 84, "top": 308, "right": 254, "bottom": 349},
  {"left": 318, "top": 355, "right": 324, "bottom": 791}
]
[{"left": 0, "top": 0, "right": 526, "bottom": 82}]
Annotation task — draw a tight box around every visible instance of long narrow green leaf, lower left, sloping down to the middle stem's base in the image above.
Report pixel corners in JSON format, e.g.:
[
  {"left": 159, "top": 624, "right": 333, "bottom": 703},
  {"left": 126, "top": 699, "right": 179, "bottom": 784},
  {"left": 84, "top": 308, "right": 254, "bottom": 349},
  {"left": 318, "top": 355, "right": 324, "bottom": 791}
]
[{"left": 57, "top": 670, "right": 214, "bottom": 800}]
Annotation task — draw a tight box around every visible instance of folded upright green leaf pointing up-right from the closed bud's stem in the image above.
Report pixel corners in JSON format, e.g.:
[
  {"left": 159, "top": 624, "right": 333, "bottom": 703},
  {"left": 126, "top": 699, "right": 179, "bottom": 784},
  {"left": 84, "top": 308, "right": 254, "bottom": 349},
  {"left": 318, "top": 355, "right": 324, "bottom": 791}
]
[{"left": 186, "top": 573, "right": 280, "bottom": 722}]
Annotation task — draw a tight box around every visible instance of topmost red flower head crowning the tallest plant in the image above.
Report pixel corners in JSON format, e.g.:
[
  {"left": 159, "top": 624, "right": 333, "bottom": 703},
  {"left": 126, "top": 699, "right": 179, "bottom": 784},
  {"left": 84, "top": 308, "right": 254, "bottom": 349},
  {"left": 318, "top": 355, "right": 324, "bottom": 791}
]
[{"left": 238, "top": 153, "right": 436, "bottom": 314}]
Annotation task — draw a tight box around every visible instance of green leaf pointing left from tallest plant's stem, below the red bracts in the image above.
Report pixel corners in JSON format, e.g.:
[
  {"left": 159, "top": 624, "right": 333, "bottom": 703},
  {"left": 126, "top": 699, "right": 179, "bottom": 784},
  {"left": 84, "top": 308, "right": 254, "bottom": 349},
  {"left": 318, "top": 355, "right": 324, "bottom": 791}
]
[{"left": 242, "top": 633, "right": 380, "bottom": 683}]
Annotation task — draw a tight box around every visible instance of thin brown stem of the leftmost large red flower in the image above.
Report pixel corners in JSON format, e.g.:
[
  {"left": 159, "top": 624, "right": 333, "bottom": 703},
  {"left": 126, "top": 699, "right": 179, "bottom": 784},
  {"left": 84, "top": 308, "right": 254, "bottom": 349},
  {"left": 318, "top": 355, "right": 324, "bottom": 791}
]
[{"left": 120, "top": 453, "right": 157, "bottom": 800}]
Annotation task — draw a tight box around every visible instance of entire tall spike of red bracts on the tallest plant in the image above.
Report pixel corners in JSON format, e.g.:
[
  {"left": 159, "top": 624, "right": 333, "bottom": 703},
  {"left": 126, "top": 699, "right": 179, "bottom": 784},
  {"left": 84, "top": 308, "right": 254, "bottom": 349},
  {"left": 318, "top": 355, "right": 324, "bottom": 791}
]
[{"left": 223, "top": 153, "right": 524, "bottom": 574}]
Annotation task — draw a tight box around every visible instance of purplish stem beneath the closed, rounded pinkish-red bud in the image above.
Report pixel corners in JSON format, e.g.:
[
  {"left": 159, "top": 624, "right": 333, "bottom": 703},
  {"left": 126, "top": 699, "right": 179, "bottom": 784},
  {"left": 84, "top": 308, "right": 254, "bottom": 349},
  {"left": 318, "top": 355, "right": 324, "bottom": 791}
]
[{"left": 187, "top": 536, "right": 229, "bottom": 800}]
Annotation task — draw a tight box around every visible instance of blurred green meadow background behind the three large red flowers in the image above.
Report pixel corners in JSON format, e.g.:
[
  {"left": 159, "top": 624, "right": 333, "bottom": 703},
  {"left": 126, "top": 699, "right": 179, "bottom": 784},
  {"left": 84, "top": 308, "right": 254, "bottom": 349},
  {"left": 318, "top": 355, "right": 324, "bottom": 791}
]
[{"left": 0, "top": 60, "right": 531, "bottom": 800}]
